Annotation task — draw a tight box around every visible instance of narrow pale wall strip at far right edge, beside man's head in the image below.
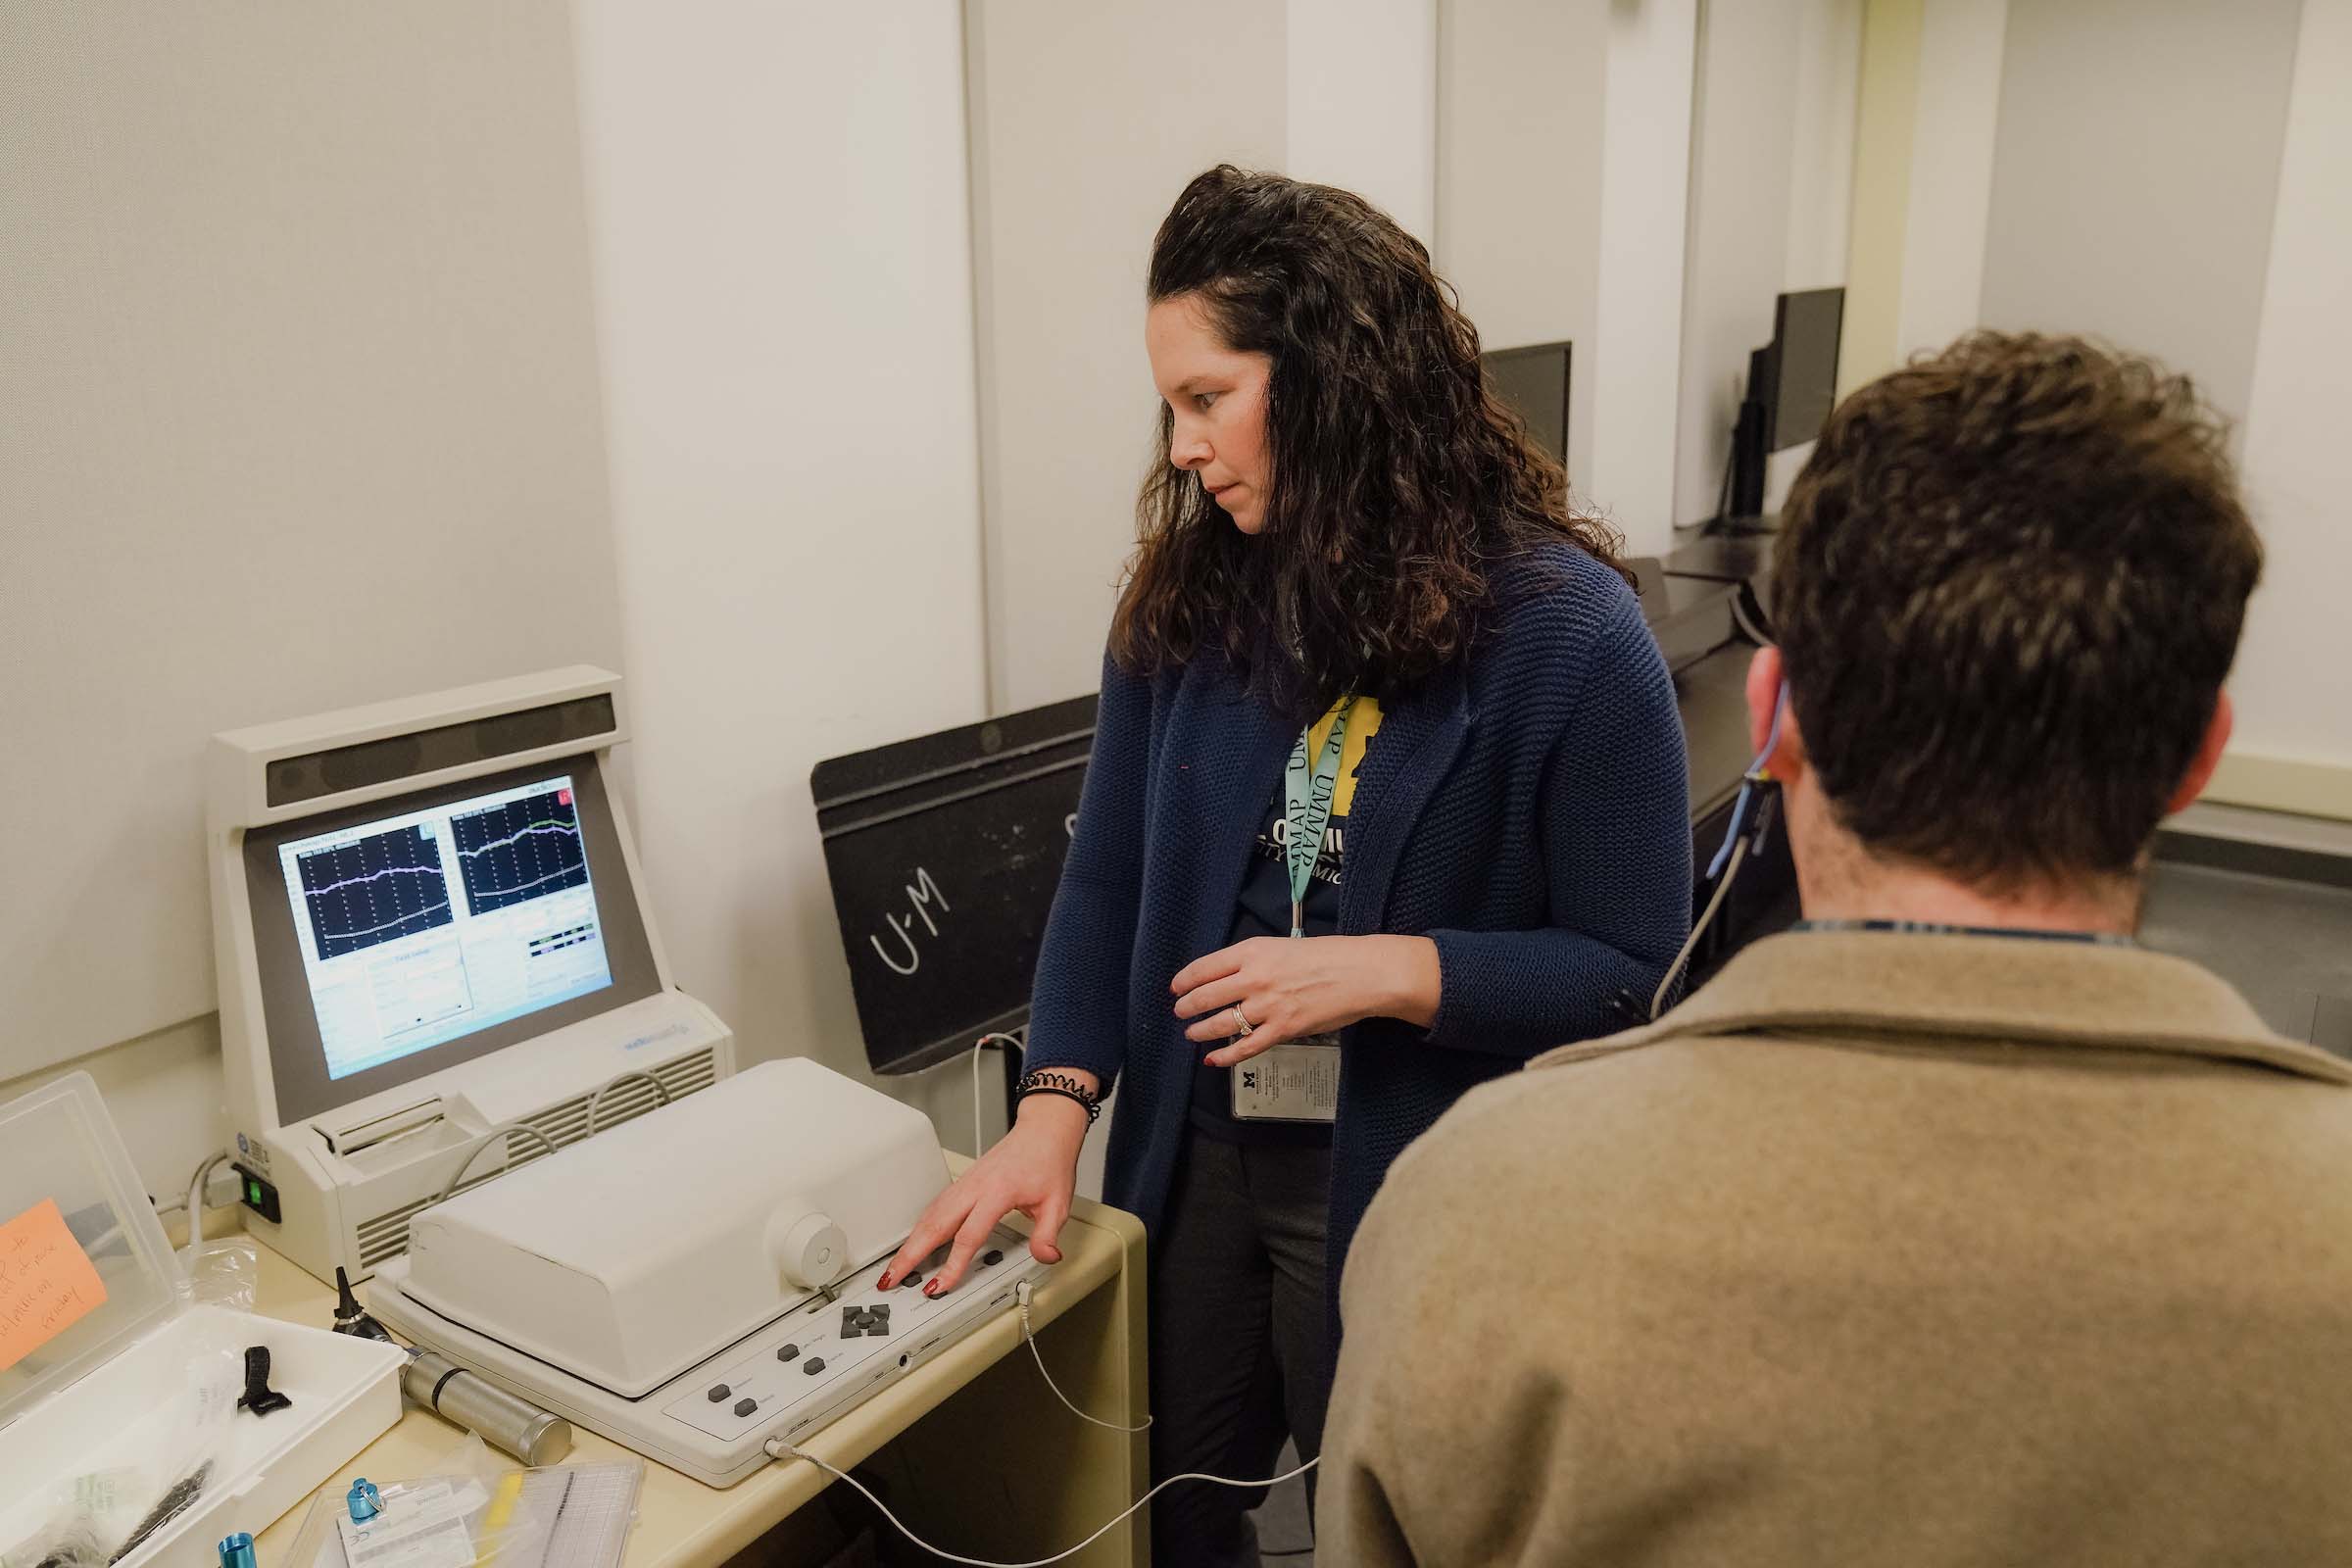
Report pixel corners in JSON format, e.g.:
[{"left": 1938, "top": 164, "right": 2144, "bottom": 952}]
[{"left": 2230, "top": 0, "right": 2352, "bottom": 768}]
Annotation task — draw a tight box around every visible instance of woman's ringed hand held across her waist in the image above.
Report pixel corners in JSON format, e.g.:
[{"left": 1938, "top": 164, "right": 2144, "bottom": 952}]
[{"left": 1169, "top": 936, "right": 1440, "bottom": 1067}]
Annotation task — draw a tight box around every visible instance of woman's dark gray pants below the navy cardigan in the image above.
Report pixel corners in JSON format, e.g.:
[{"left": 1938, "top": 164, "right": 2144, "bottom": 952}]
[{"left": 1151, "top": 1131, "right": 1331, "bottom": 1568}]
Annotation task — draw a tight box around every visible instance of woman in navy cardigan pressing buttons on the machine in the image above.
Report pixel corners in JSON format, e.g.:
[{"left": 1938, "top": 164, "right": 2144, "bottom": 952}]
[{"left": 884, "top": 167, "right": 1691, "bottom": 1563}]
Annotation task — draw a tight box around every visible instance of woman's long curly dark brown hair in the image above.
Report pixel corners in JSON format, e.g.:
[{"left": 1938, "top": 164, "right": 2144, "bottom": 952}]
[{"left": 1110, "top": 165, "right": 1623, "bottom": 712}]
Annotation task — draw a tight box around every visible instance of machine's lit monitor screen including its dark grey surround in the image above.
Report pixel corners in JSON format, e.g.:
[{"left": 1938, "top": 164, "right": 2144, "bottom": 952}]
[{"left": 245, "top": 757, "right": 659, "bottom": 1119}]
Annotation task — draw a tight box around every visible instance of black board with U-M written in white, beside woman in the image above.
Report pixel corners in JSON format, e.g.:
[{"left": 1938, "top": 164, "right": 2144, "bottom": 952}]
[{"left": 809, "top": 696, "right": 1094, "bottom": 1072}]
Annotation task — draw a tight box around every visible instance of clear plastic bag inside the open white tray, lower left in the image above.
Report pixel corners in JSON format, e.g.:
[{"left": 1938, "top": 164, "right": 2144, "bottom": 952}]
[{"left": 0, "top": 1351, "right": 245, "bottom": 1568}]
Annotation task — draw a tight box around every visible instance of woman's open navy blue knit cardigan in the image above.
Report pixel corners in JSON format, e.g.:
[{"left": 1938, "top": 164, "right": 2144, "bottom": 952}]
[{"left": 1028, "top": 543, "right": 1691, "bottom": 1293}]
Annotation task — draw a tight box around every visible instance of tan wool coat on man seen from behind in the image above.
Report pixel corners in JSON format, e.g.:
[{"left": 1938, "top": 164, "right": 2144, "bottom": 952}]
[{"left": 1317, "top": 931, "right": 2352, "bottom": 1568}]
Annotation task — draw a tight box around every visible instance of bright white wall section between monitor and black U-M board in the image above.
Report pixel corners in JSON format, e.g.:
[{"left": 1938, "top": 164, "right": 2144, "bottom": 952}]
[{"left": 578, "top": 0, "right": 986, "bottom": 1133}]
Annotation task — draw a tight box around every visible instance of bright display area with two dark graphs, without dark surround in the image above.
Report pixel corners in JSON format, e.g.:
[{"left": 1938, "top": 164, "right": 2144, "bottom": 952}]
[{"left": 277, "top": 776, "right": 612, "bottom": 1079}]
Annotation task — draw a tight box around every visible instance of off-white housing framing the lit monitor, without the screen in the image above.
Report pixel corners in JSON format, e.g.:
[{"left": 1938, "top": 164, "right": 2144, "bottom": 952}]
[{"left": 205, "top": 665, "right": 734, "bottom": 1281}]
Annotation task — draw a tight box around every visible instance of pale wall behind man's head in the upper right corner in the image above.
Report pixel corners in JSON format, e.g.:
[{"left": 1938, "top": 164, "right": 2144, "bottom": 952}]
[{"left": 1900, "top": 0, "right": 2352, "bottom": 789}]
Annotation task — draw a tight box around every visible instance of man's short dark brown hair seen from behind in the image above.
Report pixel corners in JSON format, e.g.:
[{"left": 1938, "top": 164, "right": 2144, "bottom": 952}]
[{"left": 1771, "top": 331, "right": 2263, "bottom": 891}]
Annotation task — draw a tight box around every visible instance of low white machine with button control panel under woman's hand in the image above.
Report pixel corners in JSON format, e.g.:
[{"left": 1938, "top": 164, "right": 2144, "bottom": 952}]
[{"left": 367, "top": 1057, "right": 1042, "bottom": 1486}]
